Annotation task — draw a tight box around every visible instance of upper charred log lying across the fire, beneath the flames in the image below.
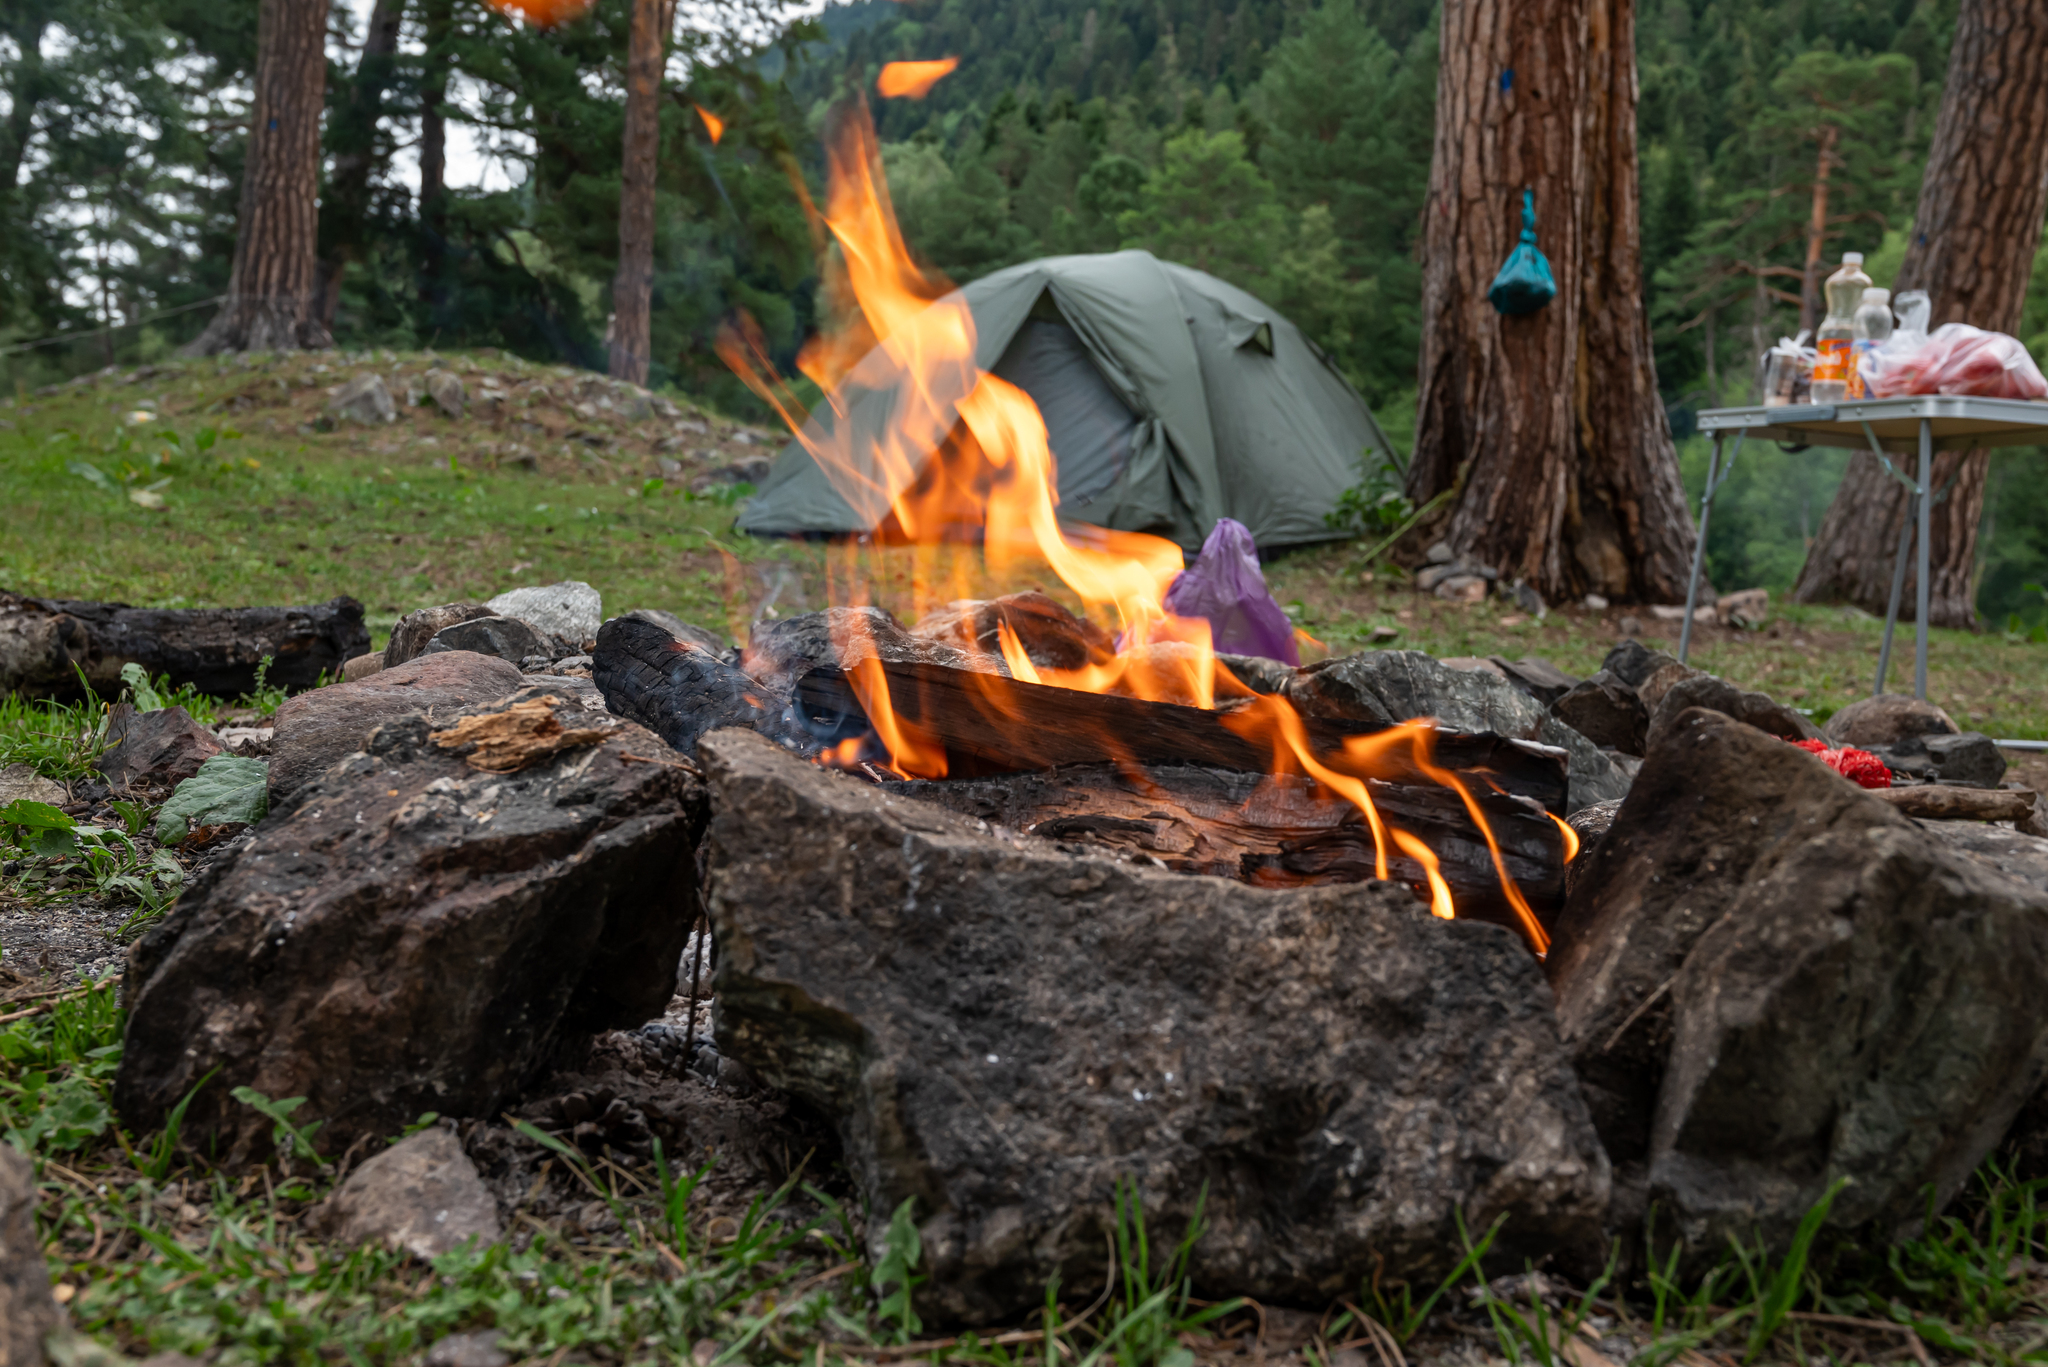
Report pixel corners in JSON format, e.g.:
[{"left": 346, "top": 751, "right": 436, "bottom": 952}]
[{"left": 795, "top": 662, "right": 1565, "bottom": 814}]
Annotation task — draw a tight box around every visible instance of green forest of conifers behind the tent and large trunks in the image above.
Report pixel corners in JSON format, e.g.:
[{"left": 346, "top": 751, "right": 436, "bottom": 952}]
[{"left": 0, "top": 0, "right": 2048, "bottom": 627}]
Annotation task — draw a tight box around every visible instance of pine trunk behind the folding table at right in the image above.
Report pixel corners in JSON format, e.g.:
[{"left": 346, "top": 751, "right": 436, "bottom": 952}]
[{"left": 1792, "top": 0, "right": 2048, "bottom": 627}]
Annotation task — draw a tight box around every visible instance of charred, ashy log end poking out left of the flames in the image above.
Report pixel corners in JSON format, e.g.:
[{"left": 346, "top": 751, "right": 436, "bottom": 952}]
[{"left": 590, "top": 617, "right": 817, "bottom": 754}]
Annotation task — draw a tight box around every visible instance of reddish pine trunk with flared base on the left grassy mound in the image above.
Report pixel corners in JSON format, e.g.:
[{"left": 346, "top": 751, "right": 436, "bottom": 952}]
[{"left": 186, "top": 0, "right": 330, "bottom": 357}]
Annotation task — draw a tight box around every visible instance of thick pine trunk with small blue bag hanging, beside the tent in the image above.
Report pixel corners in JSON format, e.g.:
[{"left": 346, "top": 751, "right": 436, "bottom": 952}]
[{"left": 1407, "top": 0, "right": 1692, "bottom": 600}]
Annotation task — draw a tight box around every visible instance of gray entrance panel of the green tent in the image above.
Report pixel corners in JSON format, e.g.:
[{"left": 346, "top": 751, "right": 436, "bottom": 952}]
[{"left": 993, "top": 316, "right": 1139, "bottom": 504}]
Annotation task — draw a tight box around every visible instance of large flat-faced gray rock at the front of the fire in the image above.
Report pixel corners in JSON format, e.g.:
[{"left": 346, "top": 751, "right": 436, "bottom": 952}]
[{"left": 698, "top": 730, "right": 1608, "bottom": 1322}]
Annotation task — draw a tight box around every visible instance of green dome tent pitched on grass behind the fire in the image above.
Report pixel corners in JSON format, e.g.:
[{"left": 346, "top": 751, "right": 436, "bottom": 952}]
[{"left": 739, "top": 252, "right": 1393, "bottom": 551}]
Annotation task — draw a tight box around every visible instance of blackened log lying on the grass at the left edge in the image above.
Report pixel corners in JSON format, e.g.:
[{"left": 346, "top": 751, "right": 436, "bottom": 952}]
[{"left": 0, "top": 592, "right": 371, "bottom": 699}]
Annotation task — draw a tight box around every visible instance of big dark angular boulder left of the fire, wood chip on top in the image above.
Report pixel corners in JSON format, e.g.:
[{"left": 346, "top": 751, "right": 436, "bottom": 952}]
[{"left": 115, "top": 688, "right": 705, "bottom": 1160}]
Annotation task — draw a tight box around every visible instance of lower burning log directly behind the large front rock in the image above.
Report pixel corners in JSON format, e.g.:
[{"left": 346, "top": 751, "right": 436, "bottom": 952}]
[{"left": 883, "top": 764, "right": 1565, "bottom": 933}]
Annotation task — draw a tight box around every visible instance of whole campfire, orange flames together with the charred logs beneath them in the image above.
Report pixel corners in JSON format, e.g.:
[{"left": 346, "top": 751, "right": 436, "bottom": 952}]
[{"left": 680, "top": 109, "right": 1575, "bottom": 955}]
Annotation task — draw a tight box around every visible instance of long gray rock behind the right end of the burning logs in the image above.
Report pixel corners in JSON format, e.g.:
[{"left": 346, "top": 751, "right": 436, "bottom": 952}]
[{"left": 1284, "top": 650, "right": 1628, "bottom": 812}]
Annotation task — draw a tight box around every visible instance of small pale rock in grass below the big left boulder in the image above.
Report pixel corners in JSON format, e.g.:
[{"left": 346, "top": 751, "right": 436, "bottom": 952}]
[{"left": 322, "top": 1127, "right": 504, "bottom": 1260}]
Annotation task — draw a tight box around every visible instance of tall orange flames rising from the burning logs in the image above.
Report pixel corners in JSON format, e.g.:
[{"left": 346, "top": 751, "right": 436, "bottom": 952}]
[{"left": 719, "top": 101, "right": 1569, "bottom": 953}]
